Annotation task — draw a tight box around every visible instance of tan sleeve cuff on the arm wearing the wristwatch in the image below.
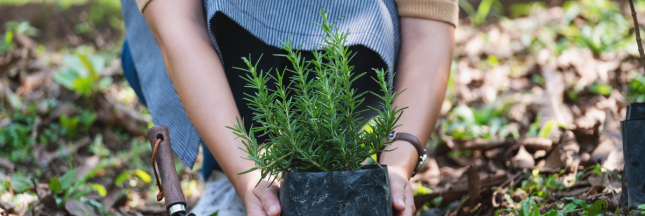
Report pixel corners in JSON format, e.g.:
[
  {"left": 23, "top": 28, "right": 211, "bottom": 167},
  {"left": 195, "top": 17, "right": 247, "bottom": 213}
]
[{"left": 395, "top": 0, "right": 459, "bottom": 27}]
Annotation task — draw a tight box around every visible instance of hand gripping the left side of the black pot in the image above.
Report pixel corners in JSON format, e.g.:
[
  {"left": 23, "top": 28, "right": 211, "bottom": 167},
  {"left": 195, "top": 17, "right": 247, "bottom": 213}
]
[{"left": 244, "top": 180, "right": 282, "bottom": 216}]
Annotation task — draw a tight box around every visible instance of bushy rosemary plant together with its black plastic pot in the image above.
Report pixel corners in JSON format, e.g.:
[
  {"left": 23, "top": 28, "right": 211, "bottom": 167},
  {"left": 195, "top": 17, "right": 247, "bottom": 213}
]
[{"left": 229, "top": 10, "right": 405, "bottom": 215}]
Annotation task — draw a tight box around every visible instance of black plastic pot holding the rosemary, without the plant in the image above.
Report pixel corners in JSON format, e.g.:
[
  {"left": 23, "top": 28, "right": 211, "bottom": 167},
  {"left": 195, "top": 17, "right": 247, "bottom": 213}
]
[{"left": 280, "top": 165, "right": 392, "bottom": 216}]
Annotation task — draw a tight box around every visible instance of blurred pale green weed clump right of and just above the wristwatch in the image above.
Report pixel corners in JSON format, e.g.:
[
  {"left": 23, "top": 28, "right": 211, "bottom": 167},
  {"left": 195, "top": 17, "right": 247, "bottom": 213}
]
[{"left": 442, "top": 101, "right": 519, "bottom": 140}]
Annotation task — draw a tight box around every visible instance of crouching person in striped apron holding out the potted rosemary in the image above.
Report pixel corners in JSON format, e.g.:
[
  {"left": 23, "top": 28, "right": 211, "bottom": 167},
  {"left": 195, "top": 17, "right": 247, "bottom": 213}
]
[{"left": 121, "top": 0, "right": 458, "bottom": 216}]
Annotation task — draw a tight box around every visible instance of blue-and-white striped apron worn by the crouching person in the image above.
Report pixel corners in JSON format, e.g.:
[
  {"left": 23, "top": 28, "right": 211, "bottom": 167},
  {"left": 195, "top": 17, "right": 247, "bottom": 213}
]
[{"left": 121, "top": 0, "right": 400, "bottom": 168}]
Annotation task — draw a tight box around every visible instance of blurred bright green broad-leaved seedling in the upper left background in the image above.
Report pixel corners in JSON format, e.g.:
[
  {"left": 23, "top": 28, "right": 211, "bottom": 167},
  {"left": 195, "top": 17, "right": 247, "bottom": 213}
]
[{"left": 54, "top": 51, "right": 112, "bottom": 99}]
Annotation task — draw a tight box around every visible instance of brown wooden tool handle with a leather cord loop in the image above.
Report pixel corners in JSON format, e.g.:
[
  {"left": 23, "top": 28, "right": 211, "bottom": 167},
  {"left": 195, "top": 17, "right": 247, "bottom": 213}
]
[{"left": 148, "top": 125, "right": 186, "bottom": 208}]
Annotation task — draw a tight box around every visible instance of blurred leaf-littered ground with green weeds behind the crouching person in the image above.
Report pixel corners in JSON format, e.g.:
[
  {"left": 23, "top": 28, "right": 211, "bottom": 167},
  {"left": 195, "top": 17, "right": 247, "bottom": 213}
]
[{"left": 0, "top": 0, "right": 645, "bottom": 216}]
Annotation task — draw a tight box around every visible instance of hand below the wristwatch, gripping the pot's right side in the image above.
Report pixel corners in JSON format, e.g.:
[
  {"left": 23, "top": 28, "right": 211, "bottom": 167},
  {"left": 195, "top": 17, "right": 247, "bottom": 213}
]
[{"left": 387, "top": 166, "right": 416, "bottom": 216}]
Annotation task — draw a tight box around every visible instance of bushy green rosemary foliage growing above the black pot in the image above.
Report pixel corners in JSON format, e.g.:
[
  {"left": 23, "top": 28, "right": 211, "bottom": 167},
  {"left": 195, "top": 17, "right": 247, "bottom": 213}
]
[{"left": 228, "top": 9, "right": 405, "bottom": 186}]
